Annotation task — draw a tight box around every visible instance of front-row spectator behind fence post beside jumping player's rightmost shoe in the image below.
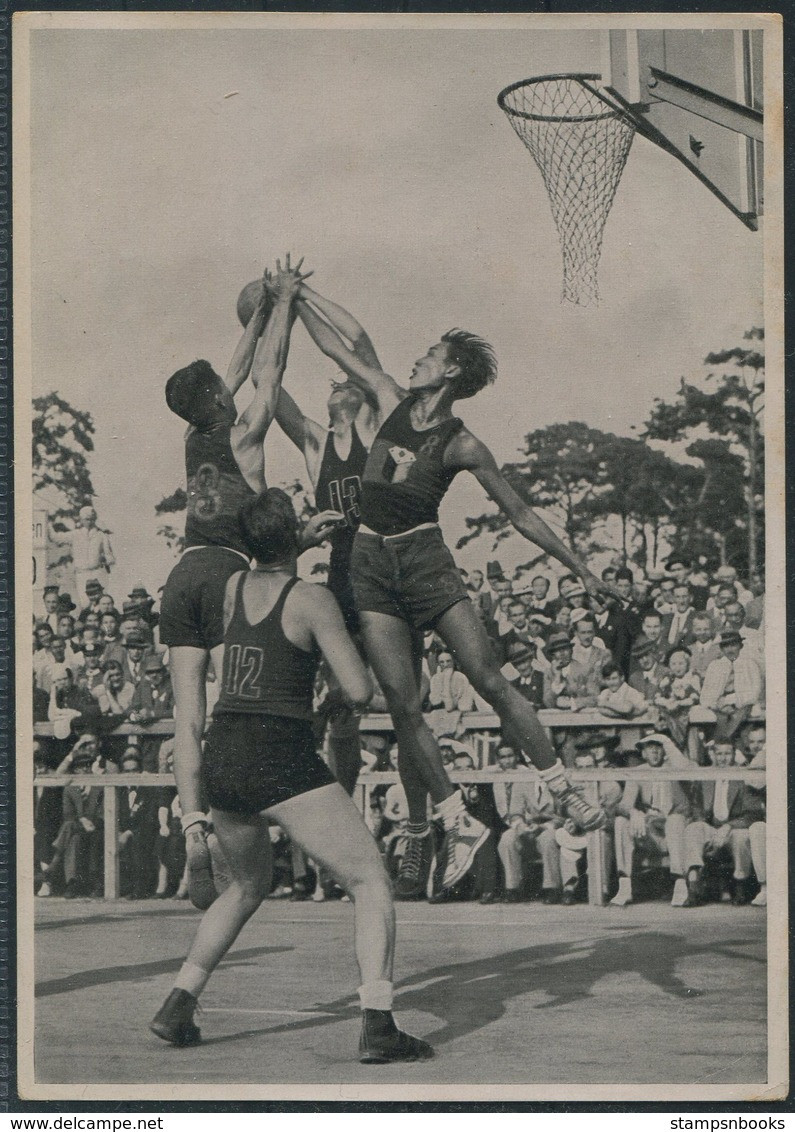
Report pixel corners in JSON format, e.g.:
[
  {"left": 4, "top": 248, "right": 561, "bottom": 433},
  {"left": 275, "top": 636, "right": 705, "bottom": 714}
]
[{"left": 555, "top": 731, "right": 622, "bottom": 906}]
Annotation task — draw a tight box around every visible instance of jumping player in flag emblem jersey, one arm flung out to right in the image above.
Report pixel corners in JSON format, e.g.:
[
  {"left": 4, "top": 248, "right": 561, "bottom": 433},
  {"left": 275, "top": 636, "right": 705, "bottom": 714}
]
[{"left": 298, "top": 298, "right": 625, "bottom": 894}]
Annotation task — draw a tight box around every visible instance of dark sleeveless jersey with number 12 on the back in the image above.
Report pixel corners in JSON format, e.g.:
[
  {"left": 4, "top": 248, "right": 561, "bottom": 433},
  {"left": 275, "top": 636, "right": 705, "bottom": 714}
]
[{"left": 214, "top": 572, "right": 318, "bottom": 720}]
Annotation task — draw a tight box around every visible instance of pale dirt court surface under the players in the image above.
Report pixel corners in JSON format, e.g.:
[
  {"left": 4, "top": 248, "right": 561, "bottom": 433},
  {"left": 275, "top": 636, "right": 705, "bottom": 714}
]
[{"left": 35, "top": 900, "right": 767, "bottom": 1084}]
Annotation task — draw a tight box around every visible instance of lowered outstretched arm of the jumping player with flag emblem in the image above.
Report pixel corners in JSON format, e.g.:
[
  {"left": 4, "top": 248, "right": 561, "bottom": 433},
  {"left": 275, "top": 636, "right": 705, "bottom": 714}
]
[{"left": 445, "top": 429, "right": 621, "bottom": 598}]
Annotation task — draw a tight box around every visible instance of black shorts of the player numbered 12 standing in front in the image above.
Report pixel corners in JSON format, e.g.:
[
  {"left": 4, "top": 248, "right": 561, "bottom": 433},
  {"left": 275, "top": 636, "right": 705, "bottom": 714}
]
[{"left": 202, "top": 712, "right": 336, "bottom": 814}]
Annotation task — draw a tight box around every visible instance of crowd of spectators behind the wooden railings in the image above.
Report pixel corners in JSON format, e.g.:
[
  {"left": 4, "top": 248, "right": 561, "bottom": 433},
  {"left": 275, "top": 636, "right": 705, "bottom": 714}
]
[{"left": 33, "top": 556, "right": 767, "bottom": 906}]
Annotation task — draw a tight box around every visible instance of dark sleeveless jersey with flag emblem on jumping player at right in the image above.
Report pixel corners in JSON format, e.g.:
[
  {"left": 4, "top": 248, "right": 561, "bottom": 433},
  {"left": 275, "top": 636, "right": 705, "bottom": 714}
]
[{"left": 360, "top": 396, "right": 463, "bottom": 534}]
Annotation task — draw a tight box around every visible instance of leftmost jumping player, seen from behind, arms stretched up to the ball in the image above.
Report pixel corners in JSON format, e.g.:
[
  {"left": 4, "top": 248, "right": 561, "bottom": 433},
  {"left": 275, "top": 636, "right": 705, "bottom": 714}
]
[{"left": 160, "top": 257, "right": 337, "bottom": 908}]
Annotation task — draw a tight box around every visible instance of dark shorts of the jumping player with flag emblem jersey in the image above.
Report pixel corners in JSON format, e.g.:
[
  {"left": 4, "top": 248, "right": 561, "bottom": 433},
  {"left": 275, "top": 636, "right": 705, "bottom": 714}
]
[{"left": 351, "top": 526, "right": 469, "bottom": 629}]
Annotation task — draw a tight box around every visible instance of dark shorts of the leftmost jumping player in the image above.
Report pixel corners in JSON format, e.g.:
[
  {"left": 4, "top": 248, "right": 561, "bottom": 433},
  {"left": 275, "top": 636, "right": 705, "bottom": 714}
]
[{"left": 160, "top": 547, "right": 248, "bottom": 649}]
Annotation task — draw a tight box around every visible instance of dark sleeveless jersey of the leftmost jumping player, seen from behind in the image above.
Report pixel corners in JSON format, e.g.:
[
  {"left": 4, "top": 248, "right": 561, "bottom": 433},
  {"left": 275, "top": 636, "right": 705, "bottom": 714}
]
[{"left": 185, "top": 425, "right": 256, "bottom": 558}]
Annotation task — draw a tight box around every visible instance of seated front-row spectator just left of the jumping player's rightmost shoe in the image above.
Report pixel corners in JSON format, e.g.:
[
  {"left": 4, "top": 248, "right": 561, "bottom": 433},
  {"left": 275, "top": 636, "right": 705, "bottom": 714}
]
[{"left": 493, "top": 744, "right": 562, "bottom": 903}]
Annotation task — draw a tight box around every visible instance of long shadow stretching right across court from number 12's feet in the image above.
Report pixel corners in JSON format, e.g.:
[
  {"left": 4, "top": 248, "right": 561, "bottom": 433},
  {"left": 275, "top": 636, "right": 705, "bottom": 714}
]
[{"left": 195, "top": 929, "right": 764, "bottom": 1045}]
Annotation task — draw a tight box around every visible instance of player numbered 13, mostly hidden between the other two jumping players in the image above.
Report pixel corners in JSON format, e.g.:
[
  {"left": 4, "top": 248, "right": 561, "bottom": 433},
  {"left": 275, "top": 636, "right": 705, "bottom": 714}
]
[{"left": 276, "top": 283, "right": 381, "bottom": 795}]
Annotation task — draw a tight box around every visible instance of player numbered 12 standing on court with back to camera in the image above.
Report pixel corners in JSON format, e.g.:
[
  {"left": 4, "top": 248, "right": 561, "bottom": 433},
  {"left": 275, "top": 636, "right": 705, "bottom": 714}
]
[{"left": 151, "top": 488, "right": 433, "bottom": 1062}]
